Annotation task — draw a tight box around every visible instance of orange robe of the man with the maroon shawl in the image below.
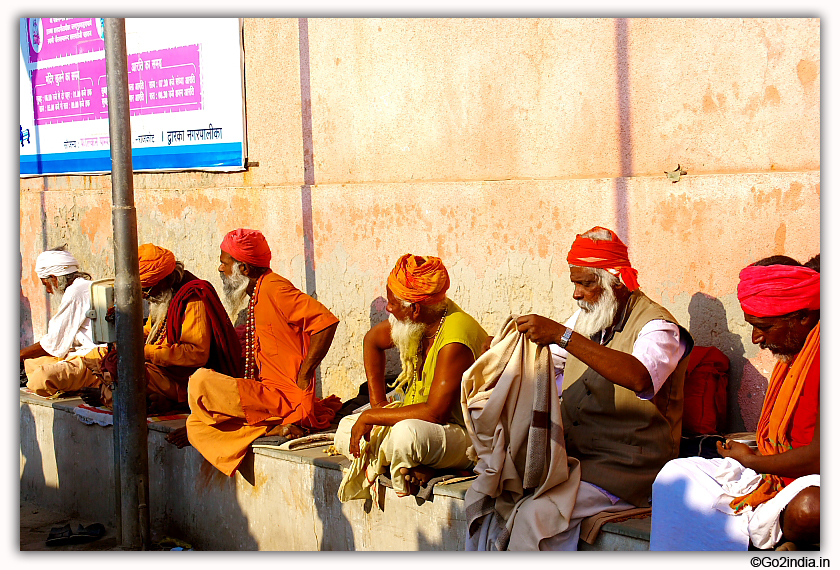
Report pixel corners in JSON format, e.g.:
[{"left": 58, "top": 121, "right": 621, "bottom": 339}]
[{"left": 143, "top": 297, "right": 213, "bottom": 403}]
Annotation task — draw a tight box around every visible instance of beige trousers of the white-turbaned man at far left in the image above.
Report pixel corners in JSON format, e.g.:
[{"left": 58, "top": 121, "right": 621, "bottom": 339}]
[{"left": 23, "top": 347, "right": 107, "bottom": 397}]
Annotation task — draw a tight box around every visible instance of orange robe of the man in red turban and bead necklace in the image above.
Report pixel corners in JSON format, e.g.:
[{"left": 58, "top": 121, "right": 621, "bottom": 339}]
[{"left": 187, "top": 272, "right": 341, "bottom": 476}]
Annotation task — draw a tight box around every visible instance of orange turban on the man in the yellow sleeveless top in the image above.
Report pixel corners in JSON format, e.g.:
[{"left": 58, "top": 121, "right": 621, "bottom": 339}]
[{"left": 388, "top": 253, "right": 449, "bottom": 305}]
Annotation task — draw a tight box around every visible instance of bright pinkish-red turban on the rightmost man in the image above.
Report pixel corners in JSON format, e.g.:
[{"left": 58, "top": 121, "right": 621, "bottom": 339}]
[{"left": 738, "top": 265, "right": 820, "bottom": 317}]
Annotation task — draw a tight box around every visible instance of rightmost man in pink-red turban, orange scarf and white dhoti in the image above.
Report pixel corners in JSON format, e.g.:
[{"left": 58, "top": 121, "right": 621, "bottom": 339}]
[{"left": 651, "top": 256, "right": 820, "bottom": 550}]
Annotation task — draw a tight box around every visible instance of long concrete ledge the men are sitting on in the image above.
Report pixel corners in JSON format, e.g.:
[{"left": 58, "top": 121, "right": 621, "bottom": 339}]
[{"left": 20, "top": 392, "right": 650, "bottom": 551}]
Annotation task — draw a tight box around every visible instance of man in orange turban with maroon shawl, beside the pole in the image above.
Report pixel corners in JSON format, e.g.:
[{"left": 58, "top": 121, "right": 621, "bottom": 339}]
[{"left": 84, "top": 243, "right": 242, "bottom": 413}]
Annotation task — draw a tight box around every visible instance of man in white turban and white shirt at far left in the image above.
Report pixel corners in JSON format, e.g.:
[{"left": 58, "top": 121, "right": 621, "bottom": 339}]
[{"left": 20, "top": 246, "right": 107, "bottom": 396}]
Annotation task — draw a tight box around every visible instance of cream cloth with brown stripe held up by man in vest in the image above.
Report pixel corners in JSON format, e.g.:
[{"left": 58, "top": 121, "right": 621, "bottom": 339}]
[{"left": 461, "top": 316, "right": 580, "bottom": 550}]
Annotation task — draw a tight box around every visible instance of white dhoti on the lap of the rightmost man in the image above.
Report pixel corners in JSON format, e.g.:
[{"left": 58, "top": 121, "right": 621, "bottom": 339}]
[{"left": 650, "top": 457, "right": 820, "bottom": 551}]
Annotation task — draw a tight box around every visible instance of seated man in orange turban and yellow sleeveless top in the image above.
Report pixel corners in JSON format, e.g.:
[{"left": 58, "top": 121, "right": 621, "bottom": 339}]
[{"left": 335, "top": 254, "right": 487, "bottom": 496}]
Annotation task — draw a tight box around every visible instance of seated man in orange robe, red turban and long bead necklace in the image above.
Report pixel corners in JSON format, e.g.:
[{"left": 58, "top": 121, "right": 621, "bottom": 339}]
[{"left": 167, "top": 229, "right": 341, "bottom": 476}]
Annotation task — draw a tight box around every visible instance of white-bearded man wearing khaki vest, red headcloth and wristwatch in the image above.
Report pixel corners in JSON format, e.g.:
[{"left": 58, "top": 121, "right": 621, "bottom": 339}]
[{"left": 517, "top": 227, "right": 694, "bottom": 550}]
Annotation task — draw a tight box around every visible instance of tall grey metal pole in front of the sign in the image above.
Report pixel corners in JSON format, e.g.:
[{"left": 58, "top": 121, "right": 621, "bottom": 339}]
[{"left": 105, "top": 18, "right": 149, "bottom": 550}]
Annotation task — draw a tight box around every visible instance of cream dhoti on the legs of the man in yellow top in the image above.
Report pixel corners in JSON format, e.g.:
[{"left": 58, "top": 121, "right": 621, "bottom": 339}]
[{"left": 335, "top": 405, "right": 472, "bottom": 496}]
